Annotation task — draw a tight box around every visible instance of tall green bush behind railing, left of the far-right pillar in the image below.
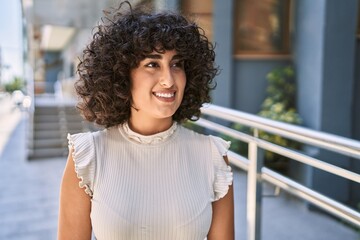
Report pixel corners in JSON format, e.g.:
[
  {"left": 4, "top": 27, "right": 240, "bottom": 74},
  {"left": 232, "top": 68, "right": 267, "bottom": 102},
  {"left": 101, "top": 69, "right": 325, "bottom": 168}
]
[{"left": 258, "top": 64, "right": 302, "bottom": 171}]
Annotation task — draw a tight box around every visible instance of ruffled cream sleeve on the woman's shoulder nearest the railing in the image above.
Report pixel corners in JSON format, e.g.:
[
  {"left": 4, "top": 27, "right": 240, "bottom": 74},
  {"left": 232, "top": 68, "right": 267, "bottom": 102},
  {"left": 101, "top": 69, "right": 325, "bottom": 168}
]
[{"left": 210, "top": 136, "right": 233, "bottom": 201}]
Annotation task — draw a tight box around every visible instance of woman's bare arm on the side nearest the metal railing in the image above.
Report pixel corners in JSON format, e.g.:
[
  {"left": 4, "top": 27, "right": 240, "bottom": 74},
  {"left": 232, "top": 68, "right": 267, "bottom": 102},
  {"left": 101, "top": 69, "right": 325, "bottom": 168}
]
[{"left": 208, "top": 156, "right": 235, "bottom": 240}]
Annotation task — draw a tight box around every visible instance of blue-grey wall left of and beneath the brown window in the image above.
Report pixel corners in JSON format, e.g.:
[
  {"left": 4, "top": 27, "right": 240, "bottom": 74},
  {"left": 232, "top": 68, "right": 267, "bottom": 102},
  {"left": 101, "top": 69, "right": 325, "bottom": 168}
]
[{"left": 213, "top": 0, "right": 291, "bottom": 113}]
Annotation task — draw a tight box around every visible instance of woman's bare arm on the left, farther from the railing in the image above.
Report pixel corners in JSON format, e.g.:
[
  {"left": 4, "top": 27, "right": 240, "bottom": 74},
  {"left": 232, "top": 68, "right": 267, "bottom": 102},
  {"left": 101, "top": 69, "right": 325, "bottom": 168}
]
[{"left": 58, "top": 150, "right": 91, "bottom": 240}]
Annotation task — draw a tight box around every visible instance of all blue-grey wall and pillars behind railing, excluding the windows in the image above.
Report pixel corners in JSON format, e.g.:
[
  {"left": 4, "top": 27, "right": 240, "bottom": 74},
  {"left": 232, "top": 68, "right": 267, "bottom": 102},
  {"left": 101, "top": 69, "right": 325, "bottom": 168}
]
[{"left": 213, "top": 0, "right": 360, "bottom": 206}]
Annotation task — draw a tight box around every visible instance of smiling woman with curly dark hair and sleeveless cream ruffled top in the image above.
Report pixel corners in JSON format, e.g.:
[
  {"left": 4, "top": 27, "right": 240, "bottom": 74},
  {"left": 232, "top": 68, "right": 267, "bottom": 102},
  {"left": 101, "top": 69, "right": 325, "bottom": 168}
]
[{"left": 58, "top": 2, "right": 234, "bottom": 240}]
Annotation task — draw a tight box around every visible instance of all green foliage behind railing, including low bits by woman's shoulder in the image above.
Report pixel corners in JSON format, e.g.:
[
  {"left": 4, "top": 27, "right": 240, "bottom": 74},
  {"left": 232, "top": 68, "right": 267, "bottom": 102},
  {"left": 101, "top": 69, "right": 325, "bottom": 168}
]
[{"left": 185, "top": 67, "right": 302, "bottom": 174}]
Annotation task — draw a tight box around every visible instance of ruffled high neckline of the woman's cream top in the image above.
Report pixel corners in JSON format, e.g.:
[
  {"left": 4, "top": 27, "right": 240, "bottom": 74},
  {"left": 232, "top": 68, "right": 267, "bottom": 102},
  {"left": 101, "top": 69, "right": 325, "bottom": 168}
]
[{"left": 119, "top": 122, "right": 177, "bottom": 145}]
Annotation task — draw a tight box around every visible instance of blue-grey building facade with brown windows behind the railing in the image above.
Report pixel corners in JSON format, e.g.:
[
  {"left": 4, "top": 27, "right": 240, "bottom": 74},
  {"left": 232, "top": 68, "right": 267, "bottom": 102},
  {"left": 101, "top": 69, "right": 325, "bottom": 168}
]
[{"left": 168, "top": 0, "right": 360, "bottom": 210}]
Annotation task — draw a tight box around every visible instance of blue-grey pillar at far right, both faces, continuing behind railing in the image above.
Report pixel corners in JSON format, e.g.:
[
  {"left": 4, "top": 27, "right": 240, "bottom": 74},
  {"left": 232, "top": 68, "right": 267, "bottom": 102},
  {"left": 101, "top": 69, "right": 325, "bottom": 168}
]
[{"left": 294, "top": 0, "right": 357, "bottom": 202}]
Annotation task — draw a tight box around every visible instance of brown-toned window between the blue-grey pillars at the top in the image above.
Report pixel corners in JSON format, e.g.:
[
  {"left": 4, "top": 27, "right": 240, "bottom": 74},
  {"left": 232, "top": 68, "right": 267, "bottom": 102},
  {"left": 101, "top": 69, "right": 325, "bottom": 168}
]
[{"left": 234, "top": 0, "right": 290, "bottom": 55}]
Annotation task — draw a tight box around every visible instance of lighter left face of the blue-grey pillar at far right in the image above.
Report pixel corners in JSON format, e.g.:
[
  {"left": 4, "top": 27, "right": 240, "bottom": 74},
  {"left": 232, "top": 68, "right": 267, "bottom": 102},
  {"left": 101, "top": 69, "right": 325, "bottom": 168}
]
[{"left": 294, "top": 0, "right": 325, "bottom": 129}]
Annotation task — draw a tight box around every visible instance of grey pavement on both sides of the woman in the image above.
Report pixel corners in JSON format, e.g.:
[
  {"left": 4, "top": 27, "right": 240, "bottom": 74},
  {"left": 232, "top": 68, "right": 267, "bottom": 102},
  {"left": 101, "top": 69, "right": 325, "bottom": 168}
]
[{"left": 0, "top": 95, "right": 360, "bottom": 240}]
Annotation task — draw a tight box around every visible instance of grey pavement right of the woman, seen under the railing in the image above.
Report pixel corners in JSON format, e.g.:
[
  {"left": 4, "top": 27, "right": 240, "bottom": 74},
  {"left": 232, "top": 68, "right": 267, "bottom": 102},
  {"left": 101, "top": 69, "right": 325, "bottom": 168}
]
[{"left": 234, "top": 171, "right": 360, "bottom": 240}]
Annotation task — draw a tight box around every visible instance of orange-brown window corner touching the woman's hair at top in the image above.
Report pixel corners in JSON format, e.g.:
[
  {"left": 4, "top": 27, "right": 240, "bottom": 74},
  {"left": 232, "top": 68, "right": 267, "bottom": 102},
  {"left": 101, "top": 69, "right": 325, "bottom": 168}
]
[{"left": 181, "top": 0, "right": 213, "bottom": 41}]
